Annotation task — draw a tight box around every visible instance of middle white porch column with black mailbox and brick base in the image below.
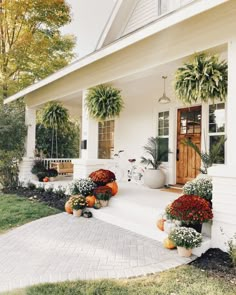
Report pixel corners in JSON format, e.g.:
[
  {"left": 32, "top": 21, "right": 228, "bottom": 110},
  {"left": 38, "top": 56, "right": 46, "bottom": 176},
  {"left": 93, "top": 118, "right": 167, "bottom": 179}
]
[{"left": 72, "top": 90, "right": 100, "bottom": 179}]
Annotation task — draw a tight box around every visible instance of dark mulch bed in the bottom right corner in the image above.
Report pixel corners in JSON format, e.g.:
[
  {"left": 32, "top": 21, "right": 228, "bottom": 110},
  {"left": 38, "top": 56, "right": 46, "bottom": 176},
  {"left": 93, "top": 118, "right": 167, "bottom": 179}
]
[{"left": 191, "top": 248, "right": 236, "bottom": 284}]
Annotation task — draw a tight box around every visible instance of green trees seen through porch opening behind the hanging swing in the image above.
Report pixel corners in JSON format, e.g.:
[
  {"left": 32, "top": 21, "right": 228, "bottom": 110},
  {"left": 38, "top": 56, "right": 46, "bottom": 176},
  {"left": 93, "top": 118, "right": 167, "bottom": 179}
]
[{"left": 36, "top": 121, "right": 80, "bottom": 158}]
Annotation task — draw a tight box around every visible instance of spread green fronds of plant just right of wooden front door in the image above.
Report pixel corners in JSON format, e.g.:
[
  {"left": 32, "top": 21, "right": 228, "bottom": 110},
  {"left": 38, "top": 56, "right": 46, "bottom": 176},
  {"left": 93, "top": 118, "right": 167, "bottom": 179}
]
[{"left": 182, "top": 136, "right": 227, "bottom": 174}]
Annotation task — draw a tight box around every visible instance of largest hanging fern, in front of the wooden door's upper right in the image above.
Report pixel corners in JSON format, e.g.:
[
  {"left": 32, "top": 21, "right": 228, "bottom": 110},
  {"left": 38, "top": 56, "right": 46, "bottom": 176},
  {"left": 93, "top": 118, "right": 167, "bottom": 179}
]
[{"left": 175, "top": 53, "right": 228, "bottom": 104}]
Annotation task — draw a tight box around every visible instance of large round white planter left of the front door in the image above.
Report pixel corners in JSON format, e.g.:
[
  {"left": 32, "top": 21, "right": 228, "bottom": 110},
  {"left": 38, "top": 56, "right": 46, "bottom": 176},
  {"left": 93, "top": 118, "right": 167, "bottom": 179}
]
[{"left": 143, "top": 169, "right": 165, "bottom": 188}]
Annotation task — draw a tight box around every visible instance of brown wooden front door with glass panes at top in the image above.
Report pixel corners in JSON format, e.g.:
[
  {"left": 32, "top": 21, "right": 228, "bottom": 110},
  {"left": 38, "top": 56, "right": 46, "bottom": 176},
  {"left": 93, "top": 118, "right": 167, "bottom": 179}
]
[{"left": 176, "top": 106, "right": 202, "bottom": 184}]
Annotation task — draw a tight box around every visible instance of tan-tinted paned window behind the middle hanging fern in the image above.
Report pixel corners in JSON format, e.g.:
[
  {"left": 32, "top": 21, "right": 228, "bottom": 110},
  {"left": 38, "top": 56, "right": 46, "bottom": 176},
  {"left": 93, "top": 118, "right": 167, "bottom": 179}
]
[{"left": 98, "top": 120, "right": 115, "bottom": 159}]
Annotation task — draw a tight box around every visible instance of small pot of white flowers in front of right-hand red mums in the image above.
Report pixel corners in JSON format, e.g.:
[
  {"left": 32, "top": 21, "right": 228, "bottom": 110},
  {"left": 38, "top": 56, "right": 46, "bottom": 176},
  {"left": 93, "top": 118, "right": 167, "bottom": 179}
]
[{"left": 169, "top": 227, "right": 202, "bottom": 257}]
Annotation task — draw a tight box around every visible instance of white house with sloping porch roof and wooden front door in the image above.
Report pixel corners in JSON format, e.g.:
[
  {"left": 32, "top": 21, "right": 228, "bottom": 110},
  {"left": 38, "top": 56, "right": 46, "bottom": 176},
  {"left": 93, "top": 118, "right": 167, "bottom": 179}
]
[{"left": 5, "top": 0, "right": 236, "bottom": 249}]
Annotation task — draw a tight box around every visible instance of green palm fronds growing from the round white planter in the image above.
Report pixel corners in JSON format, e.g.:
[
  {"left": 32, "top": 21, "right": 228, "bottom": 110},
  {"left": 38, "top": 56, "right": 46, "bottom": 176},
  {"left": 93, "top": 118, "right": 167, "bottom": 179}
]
[{"left": 141, "top": 136, "right": 170, "bottom": 169}]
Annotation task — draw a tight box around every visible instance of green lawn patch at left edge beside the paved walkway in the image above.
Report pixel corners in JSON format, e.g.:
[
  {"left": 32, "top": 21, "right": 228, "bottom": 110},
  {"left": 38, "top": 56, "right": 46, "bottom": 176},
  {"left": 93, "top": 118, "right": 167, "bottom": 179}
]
[{"left": 0, "top": 194, "right": 60, "bottom": 233}]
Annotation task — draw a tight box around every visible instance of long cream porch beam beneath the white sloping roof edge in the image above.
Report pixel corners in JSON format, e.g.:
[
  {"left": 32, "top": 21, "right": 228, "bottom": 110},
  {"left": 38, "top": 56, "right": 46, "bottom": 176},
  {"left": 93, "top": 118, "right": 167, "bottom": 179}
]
[{"left": 14, "top": 1, "right": 236, "bottom": 107}]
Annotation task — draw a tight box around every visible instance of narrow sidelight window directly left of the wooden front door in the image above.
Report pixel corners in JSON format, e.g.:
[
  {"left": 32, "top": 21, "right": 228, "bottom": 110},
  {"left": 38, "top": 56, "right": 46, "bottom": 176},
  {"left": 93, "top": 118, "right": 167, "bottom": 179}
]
[{"left": 158, "top": 112, "right": 169, "bottom": 162}]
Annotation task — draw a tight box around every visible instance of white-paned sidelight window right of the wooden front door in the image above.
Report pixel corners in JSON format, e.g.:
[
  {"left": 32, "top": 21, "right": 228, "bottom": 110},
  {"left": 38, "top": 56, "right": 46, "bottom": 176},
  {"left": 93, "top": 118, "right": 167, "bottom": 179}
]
[{"left": 209, "top": 103, "right": 225, "bottom": 164}]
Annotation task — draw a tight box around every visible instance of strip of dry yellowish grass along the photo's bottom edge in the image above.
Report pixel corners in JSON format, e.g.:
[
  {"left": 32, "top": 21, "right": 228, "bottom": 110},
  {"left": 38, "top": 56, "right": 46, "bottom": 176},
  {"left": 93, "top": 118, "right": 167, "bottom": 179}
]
[{"left": 4, "top": 265, "right": 236, "bottom": 295}]
